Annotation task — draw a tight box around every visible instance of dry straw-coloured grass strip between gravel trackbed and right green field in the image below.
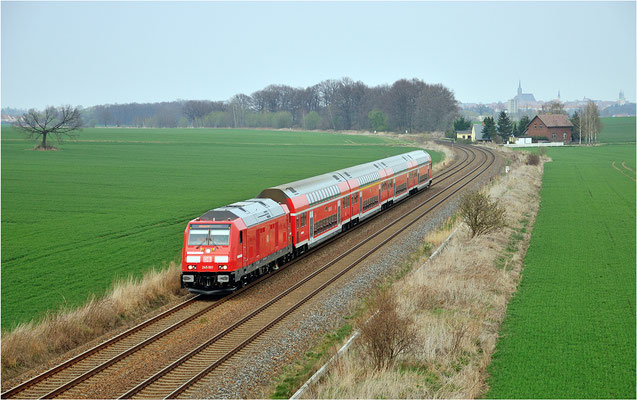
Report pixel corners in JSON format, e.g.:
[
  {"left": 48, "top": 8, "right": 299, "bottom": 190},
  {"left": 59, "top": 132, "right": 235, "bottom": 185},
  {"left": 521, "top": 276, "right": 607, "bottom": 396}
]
[{"left": 305, "top": 153, "right": 542, "bottom": 398}]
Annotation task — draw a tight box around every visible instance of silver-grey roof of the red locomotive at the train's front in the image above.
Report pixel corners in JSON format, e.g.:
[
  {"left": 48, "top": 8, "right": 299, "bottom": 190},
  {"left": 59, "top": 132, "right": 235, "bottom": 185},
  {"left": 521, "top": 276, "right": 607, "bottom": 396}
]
[{"left": 199, "top": 198, "right": 285, "bottom": 227}]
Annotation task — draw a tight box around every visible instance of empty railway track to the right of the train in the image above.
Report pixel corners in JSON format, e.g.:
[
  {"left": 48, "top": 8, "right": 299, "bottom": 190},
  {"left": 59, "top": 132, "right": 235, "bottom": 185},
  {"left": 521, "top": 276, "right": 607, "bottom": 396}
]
[{"left": 120, "top": 145, "right": 495, "bottom": 399}]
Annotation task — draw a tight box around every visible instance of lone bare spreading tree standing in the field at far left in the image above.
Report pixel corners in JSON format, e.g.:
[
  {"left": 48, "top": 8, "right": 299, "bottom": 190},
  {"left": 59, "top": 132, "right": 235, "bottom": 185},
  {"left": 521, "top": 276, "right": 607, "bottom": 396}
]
[{"left": 15, "top": 106, "right": 82, "bottom": 150}]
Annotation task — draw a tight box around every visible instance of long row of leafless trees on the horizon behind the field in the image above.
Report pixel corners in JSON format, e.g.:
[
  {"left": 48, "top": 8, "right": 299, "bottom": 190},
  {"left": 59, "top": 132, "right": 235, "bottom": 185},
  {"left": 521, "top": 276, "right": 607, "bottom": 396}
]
[{"left": 84, "top": 78, "right": 459, "bottom": 132}]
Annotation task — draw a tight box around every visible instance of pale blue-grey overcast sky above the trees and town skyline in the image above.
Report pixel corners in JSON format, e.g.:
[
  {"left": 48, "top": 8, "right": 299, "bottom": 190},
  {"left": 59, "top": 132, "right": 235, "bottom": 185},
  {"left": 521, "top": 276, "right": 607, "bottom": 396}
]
[{"left": 1, "top": 1, "right": 636, "bottom": 108}]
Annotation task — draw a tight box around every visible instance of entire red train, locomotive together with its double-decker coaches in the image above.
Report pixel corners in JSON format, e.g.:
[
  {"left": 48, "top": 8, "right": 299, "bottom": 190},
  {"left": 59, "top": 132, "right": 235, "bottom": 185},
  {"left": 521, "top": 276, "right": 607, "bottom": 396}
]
[{"left": 181, "top": 150, "right": 432, "bottom": 294}]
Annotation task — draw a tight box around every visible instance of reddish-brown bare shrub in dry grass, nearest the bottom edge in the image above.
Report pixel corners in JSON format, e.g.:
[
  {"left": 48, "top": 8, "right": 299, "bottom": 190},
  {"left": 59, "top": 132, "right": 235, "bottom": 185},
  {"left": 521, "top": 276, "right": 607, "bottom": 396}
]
[{"left": 358, "top": 291, "right": 416, "bottom": 370}]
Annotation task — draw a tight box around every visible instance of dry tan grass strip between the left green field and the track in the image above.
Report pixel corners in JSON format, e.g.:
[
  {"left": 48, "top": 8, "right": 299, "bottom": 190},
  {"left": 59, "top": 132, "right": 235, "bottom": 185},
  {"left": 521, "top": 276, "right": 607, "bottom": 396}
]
[{"left": 2, "top": 263, "right": 184, "bottom": 382}]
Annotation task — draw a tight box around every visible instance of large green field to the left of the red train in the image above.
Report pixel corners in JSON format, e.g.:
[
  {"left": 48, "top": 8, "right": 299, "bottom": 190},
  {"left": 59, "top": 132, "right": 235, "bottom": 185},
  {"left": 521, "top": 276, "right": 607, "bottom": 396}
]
[{"left": 2, "top": 127, "right": 441, "bottom": 329}]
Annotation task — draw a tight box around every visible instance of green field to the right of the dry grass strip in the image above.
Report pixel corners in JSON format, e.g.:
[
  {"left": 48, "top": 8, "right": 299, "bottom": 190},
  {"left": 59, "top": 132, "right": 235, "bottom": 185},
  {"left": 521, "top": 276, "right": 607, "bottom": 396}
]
[{"left": 487, "top": 144, "right": 636, "bottom": 398}]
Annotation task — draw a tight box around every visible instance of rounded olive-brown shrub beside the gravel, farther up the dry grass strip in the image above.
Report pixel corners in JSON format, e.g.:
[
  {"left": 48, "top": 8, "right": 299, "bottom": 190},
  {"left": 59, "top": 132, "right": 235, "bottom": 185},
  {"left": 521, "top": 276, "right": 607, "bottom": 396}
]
[{"left": 460, "top": 191, "right": 506, "bottom": 237}]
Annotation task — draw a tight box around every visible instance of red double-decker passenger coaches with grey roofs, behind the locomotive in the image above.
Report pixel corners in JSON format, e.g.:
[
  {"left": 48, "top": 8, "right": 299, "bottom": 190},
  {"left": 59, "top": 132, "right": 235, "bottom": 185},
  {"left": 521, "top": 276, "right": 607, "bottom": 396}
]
[{"left": 258, "top": 150, "right": 432, "bottom": 253}]
